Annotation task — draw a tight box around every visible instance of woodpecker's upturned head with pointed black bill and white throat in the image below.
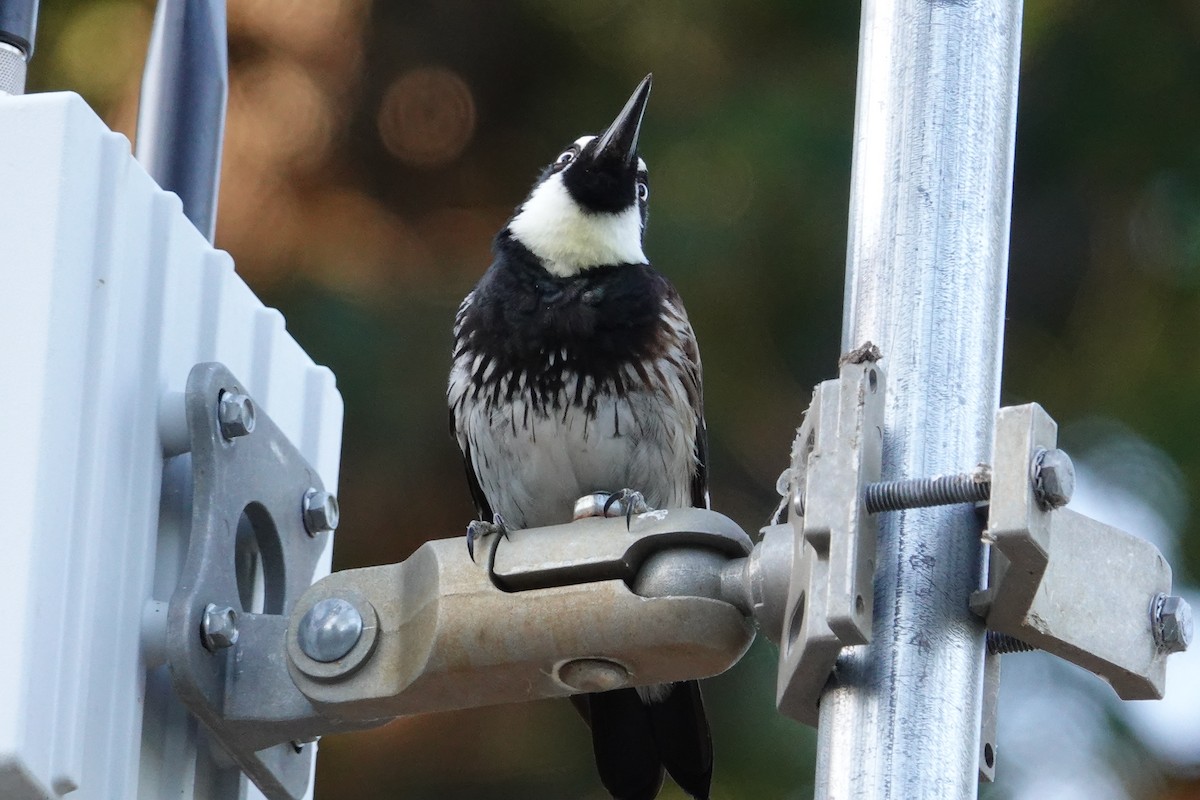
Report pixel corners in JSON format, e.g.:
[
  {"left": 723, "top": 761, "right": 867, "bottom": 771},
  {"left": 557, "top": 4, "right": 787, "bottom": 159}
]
[{"left": 508, "top": 76, "right": 652, "bottom": 277}]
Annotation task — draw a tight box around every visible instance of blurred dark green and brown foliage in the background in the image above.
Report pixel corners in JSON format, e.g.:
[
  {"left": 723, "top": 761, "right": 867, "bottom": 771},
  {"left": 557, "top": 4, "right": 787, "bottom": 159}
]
[{"left": 31, "top": 0, "right": 1200, "bottom": 800}]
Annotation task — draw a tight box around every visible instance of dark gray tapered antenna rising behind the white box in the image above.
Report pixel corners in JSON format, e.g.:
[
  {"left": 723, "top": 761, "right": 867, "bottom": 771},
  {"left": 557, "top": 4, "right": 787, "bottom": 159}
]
[{"left": 137, "top": 0, "right": 229, "bottom": 241}]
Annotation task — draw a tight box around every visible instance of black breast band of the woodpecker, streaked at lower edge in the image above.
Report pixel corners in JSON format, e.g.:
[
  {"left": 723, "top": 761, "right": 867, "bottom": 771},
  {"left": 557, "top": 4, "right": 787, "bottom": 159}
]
[{"left": 455, "top": 234, "right": 671, "bottom": 408}]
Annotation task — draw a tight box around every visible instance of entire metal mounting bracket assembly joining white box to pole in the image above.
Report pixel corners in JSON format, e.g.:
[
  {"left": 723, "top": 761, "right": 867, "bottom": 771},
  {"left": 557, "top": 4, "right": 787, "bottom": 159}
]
[{"left": 163, "top": 367, "right": 1190, "bottom": 800}]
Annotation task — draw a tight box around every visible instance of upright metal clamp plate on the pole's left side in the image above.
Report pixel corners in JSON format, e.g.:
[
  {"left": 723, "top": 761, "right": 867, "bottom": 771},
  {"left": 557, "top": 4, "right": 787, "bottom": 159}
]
[{"left": 768, "top": 356, "right": 884, "bottom": 726}]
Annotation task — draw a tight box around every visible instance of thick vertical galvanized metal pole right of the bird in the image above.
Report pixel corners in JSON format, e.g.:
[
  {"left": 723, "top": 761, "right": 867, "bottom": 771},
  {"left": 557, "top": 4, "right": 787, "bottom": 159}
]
[{"left": 816, "top": 0, "right": 1021, "bottom": 800}]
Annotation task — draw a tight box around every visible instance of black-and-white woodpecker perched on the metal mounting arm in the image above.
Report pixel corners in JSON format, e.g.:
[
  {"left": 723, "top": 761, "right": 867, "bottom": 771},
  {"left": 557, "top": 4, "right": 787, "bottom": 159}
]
[{"left": 446, "top": 76, "right": 713, "bottom": 800}]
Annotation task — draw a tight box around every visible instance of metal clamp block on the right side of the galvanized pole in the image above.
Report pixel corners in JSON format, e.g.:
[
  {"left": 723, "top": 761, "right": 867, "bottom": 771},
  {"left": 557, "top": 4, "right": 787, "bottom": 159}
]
[{"left": 971, "top": 403, "right": 1176, "bottom": 700}]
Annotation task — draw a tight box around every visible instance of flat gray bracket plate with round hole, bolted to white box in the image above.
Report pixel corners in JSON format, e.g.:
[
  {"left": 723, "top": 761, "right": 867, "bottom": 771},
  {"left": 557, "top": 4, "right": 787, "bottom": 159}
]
[{"left": 162, "top": 363, "right": 336, "bottom": 798}]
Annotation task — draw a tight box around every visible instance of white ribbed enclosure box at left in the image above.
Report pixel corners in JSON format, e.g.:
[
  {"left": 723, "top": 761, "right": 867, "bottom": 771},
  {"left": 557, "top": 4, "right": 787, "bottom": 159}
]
[{"left": 0, "top": 94, "right": 342, "bottom": 800}]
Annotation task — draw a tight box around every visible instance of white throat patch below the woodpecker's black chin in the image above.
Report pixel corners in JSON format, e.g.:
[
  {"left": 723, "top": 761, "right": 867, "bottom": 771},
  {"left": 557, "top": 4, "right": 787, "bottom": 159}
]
[{"left": 509, "top": 173, "right": 646, "bottom": 278}]
